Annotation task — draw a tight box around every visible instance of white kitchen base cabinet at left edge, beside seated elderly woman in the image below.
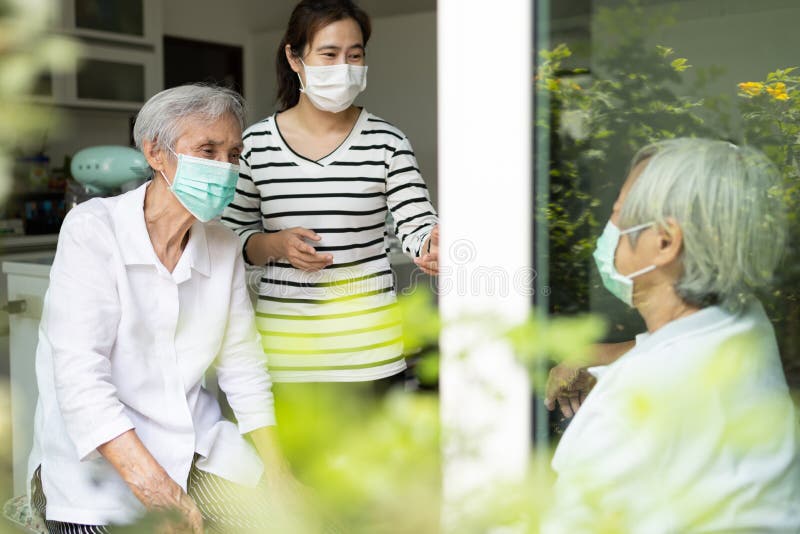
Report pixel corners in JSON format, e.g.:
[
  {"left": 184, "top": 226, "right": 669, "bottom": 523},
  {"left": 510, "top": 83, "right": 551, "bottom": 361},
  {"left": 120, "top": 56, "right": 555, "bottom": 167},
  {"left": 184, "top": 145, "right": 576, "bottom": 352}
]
[{"left": 3, "top": 255, "right": 53, "bottom": 495}]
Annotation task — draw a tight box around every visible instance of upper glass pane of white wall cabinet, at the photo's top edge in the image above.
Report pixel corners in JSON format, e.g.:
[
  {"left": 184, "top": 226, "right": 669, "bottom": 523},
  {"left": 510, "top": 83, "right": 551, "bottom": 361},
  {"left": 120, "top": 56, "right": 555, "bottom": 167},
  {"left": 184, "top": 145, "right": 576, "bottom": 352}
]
[{"left": 75, "top": 0, "right": 144, "bottom": 36}]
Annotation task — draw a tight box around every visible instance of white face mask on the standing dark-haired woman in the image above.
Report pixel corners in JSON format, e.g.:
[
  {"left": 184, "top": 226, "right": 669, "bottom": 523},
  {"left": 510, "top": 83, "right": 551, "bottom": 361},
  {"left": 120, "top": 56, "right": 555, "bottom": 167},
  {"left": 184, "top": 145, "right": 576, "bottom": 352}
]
[{"left": 297, "top": 59, "right": 367, "bottom": 113}]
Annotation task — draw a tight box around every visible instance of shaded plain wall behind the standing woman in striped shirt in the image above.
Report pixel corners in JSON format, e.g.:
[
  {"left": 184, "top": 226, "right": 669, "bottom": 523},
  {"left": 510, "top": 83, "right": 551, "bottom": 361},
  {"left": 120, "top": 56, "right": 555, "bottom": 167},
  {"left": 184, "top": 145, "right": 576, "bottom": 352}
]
[{"left": 247, "top": 11, "right": 438, "bottom": 205}]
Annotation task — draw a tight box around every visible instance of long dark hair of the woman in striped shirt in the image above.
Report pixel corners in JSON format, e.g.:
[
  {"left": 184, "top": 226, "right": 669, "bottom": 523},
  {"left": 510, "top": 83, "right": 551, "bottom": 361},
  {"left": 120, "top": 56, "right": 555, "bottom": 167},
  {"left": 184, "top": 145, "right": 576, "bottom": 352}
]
[{"left": 275, "top": 0, "right": 372, "bottom": 111}]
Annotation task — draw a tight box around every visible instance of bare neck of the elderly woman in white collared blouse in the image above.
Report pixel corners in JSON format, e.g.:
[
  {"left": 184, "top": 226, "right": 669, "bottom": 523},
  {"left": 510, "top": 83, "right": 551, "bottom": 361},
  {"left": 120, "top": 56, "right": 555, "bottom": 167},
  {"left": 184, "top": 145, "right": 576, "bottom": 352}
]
[{"left": 144, "top": 179, "right": 195, "bottom": 271}]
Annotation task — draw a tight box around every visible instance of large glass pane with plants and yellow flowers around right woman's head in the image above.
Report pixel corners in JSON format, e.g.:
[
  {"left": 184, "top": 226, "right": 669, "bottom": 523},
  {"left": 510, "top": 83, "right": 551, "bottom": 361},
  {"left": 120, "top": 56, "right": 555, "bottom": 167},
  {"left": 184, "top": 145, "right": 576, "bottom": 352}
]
[{"left": 536, "top": 0, "right": 800, "bottom": 428}]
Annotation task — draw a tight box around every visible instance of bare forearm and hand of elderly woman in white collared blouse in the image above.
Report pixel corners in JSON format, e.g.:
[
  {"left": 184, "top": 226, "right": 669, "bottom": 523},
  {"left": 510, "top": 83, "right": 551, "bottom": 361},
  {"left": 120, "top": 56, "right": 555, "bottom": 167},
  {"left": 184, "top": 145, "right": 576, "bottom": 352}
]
[{"left": 97, "top": 430, "right": 203, "bottom": 534}]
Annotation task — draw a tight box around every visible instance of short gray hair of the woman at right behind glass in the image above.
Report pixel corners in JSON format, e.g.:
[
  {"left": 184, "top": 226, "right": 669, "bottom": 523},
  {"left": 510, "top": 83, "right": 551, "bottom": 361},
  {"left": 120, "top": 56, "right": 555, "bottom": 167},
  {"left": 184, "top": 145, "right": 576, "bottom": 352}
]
[{"left": 620, "top": 138, "right": 787, "bottom": 309}]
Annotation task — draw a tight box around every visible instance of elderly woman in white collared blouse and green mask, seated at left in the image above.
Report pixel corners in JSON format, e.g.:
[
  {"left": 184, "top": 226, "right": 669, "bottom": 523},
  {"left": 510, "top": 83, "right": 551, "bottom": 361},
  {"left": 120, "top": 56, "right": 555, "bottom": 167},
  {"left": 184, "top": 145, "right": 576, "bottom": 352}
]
[{"left": 29, "top": 85, "right": 302, "bottom": 533}]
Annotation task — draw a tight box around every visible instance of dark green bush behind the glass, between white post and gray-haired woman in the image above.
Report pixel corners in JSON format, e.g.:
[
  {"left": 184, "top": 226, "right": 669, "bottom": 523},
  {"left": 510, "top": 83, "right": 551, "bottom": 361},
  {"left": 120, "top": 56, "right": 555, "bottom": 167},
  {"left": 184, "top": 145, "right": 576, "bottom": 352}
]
[{"left": 536, "top": 1, "right": 708, "bottom": 313}]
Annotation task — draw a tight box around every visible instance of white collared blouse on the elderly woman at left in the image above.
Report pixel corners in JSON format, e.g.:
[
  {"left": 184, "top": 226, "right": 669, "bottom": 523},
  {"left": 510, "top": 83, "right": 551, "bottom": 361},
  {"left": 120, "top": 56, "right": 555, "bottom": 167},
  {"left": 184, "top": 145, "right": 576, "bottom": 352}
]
[{"left": 29, "top": 184, "right": 275, "bottom": 524}]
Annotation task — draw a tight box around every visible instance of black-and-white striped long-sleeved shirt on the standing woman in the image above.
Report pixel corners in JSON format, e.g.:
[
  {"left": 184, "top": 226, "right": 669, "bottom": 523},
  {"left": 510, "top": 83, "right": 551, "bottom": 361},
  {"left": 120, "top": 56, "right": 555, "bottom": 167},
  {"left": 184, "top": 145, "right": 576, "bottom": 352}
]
[{"left": 222, "top": 110, "right": 437, "bottom": 382}]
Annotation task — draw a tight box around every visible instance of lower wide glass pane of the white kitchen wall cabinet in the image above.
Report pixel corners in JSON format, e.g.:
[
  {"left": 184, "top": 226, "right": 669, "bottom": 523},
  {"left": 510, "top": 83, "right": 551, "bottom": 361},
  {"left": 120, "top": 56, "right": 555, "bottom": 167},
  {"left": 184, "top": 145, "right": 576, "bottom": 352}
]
[{"left": 78, "top": 59, "right": 145, "bottom": 102}]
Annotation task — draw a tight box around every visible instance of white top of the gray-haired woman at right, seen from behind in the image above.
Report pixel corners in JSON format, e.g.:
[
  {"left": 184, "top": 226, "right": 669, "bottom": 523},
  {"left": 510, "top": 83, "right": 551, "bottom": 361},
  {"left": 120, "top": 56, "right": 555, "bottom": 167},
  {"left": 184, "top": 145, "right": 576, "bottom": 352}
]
[{"left": 543, "top": 302, "right": 800, "bottom": 534}]
